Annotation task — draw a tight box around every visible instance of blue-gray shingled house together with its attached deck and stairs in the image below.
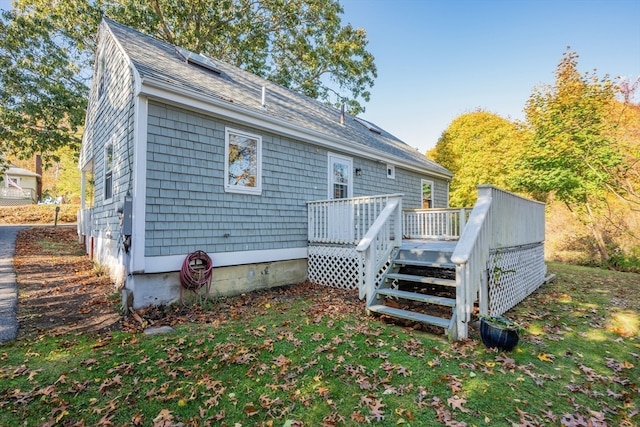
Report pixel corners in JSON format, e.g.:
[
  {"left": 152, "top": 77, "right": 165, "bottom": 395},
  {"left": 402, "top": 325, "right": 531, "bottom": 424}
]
[{"left": 78, "top": 19, "right": 546, "bottom": 339}]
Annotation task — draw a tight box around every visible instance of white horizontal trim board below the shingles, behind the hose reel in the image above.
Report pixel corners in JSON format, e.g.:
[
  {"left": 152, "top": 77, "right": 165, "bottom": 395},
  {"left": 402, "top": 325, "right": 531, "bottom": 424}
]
[{"left": 143, "top": 247, "right": 307, "bottom": 274}]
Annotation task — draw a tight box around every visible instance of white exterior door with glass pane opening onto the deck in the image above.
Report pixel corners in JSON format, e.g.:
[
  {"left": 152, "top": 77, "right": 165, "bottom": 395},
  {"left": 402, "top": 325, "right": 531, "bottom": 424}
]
[{"left": 328, "top": 153, "right": 354, "bottom": 242}]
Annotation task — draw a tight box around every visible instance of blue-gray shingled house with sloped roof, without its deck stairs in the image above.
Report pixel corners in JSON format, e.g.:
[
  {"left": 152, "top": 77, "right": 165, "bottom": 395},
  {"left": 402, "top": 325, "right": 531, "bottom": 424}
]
[{"left": 78, "top": 19, "right": 452, "bottom": 307}]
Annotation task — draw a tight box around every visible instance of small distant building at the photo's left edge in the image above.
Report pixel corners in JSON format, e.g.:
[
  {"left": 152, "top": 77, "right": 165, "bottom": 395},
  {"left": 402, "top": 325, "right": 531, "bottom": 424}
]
[{"left": 0, "top": 165, "right": 42, "bottom": 206}]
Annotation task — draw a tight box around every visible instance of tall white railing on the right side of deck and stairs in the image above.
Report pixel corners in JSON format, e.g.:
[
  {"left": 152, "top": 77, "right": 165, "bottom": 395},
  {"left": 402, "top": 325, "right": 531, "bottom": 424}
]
[{"left": 451, "top": 185, "right": 545, "bottom": 339}]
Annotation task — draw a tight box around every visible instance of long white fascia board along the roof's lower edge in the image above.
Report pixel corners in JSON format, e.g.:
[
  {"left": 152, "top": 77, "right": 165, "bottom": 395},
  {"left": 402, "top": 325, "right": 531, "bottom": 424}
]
[{"left": 139, "top": 76, "right": 451, "bottom": 180}]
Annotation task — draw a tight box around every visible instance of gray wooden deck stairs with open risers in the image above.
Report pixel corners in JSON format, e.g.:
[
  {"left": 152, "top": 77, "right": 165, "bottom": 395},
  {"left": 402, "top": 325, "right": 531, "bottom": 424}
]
[{"left": 367, "top": 240, "right": 456, "bottom": 335}]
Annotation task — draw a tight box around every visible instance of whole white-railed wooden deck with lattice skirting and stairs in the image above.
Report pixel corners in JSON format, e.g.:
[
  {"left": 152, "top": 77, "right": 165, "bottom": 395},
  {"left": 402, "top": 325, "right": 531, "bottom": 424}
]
[{"left": 308, "top": 186, "right": 546, "bottom": 340}]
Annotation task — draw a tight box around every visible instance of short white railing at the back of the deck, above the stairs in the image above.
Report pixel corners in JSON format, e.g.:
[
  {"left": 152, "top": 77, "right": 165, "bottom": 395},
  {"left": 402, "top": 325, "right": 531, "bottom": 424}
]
[{"left": 402, "top": 208, "right": 471, "bottom": 239}]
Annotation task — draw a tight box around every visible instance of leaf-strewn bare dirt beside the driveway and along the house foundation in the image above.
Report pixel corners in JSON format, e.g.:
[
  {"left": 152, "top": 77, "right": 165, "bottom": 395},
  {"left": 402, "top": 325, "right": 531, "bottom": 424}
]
[{"left": 14, "top": 226, "right": 365, "bottom": 337}]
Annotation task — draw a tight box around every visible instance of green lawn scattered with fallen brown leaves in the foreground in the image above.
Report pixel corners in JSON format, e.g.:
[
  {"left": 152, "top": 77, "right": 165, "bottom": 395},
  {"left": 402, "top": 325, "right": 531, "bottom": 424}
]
[{"left": 0, "top": 264, "right": 640, "bottom": 426}]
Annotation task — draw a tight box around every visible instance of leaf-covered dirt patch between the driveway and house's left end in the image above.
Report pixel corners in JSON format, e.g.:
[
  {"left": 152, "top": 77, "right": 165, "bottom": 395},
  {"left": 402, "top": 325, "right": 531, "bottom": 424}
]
[{"left": 14, "top": 226, "right": 121, "bottom": 336}]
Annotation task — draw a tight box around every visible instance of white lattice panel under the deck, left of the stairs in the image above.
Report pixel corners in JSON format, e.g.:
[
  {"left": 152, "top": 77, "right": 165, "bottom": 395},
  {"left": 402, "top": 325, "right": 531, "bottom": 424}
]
[{"left": 308, "top": 245, "right": 364, "bottom": 289}]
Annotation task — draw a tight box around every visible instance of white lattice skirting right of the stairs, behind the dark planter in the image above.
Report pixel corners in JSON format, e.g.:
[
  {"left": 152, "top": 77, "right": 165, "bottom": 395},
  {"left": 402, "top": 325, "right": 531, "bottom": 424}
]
[{"left": 487, "top": 244, "right": 547, "bottom": 316}]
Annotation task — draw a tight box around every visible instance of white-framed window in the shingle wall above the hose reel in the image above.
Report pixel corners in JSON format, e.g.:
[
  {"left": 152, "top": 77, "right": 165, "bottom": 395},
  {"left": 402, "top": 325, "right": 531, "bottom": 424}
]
[{"left": 224, "top": 129, "right": 262, "bottom": 194}]
